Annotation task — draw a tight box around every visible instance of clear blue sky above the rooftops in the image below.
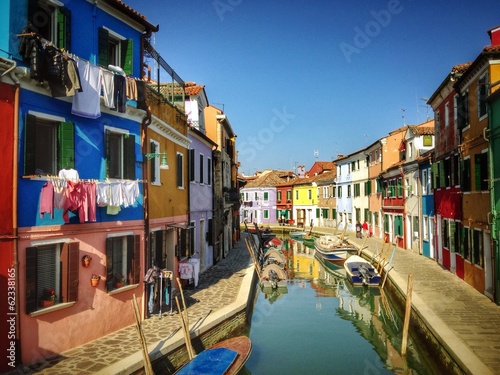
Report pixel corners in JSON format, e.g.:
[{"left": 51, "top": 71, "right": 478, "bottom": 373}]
[{"left": 124, "top": 0, "right": 500, "bottom": 175}]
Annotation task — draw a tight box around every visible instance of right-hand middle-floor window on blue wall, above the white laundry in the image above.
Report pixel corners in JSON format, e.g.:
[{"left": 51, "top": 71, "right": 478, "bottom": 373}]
[{"left": 105, "top": 127, "right": 135, "bottom": 180}]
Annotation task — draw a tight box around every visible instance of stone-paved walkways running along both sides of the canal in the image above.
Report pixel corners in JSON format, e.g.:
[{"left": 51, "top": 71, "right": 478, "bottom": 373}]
[{"left": 6, "top": 227, "right": 500, "bottom": 375}]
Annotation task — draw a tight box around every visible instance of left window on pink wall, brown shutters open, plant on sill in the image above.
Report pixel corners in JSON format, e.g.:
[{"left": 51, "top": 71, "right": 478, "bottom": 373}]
[{"left": 26, "top": 242, "right": 80, "bottom": 314}]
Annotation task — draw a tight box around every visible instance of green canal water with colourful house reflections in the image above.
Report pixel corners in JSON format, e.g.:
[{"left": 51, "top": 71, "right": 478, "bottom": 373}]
[{"left": 241, "top": 242, "right": 440, "bottom": 375}]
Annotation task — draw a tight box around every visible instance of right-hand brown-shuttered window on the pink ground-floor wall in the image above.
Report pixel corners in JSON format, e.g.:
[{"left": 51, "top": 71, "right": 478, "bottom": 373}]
[{"left": 106, "top": 235, "right": 141, "bottom": 292}]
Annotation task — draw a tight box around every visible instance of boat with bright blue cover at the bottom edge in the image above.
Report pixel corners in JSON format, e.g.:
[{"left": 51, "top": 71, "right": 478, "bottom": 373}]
[{"left": 175, "top": 336, "right": 252, "bottom": 375}]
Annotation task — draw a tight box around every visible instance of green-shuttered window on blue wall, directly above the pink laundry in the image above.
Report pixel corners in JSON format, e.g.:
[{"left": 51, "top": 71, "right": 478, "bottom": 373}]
[{"left": 24, "top": 112, "right": 75, "bottom": 175}]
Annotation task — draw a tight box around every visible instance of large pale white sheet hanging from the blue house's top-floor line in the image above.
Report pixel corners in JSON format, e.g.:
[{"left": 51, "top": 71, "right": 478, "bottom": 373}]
[{"left": 71, "top": 60, "right": 102, "bottom": 119}]
